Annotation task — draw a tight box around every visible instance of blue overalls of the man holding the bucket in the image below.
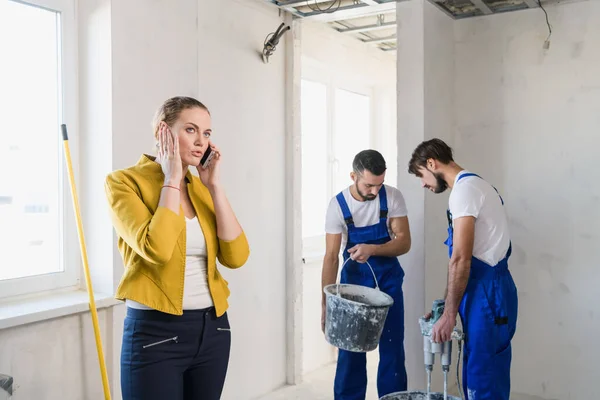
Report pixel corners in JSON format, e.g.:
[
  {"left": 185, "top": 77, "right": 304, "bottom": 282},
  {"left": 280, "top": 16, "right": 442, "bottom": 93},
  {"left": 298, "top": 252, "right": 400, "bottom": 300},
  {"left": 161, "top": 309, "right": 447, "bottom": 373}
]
[{"left": 334, "top": 186, "right": 407, "bottom": 400}]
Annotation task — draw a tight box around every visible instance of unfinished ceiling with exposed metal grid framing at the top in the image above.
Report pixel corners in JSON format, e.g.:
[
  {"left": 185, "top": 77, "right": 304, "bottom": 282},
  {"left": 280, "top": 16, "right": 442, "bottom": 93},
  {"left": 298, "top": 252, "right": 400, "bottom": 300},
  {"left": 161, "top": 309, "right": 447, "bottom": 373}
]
[{"left": 266, "top": 0, "right": 558, "bottom": 51}]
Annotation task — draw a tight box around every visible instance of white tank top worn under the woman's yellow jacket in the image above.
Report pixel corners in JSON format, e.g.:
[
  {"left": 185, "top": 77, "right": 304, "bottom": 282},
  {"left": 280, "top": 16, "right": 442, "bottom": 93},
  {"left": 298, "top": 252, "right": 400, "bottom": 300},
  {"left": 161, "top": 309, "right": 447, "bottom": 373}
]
[{"left": 125, "top": 217, "right": 214, "bottom": 310}]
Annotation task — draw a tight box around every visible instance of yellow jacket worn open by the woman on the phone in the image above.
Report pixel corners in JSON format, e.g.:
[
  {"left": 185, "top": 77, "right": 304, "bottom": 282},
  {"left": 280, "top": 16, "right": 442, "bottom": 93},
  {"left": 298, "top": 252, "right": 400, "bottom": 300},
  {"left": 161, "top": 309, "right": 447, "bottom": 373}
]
[{"left": 105, "top": 155, "right": 250, "bottom": 316}]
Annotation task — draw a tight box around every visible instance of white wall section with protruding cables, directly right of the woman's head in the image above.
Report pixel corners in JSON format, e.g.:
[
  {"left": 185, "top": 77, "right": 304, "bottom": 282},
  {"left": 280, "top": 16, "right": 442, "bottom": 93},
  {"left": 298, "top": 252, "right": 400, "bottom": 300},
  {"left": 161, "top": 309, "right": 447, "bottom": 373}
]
[{"left": 198, "top": 0, "right": 289, "bottom": 400}]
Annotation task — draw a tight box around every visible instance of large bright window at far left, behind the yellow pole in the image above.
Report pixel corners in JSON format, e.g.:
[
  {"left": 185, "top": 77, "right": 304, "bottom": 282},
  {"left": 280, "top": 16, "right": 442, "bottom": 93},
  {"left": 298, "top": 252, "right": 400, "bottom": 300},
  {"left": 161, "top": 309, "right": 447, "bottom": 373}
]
[{"left": 0, "top": 0, "right": 79, "bottom": 297}]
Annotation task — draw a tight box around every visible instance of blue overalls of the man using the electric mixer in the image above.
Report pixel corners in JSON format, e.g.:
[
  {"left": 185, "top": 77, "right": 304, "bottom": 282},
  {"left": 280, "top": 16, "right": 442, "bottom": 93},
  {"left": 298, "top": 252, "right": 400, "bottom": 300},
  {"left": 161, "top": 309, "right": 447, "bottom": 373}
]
[{"left": 445, "top": 173, "right": 518, "bottom": 400}]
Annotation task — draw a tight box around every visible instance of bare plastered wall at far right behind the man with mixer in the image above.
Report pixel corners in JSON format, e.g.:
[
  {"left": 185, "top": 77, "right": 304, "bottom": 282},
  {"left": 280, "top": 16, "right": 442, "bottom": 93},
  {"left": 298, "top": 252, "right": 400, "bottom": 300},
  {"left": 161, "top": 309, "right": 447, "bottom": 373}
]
[{"left": 455, "top": 1, "right": 600, "bottom": 399}]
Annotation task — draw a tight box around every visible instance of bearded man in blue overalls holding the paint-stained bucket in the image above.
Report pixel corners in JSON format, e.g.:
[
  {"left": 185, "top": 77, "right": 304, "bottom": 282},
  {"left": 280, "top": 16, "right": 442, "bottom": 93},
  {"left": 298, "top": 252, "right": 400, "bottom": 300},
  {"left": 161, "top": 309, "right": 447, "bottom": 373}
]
[{"left": 321, "top": 150, "right": 410, "bottom": 400}]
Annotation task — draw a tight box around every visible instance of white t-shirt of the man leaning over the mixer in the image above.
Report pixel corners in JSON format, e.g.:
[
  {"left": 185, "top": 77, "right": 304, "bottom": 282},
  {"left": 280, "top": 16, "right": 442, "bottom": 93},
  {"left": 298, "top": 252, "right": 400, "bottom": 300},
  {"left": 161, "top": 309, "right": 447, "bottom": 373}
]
[{"left": 448, "top": 170, "right": 510, "bottom": 266}]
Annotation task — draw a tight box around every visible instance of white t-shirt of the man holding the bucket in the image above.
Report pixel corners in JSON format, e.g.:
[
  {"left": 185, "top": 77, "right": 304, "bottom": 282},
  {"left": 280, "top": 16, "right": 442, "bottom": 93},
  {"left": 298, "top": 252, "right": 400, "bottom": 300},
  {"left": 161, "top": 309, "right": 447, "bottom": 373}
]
[{"left": 325, "top": 185, "right": 408, "bottom": 248}]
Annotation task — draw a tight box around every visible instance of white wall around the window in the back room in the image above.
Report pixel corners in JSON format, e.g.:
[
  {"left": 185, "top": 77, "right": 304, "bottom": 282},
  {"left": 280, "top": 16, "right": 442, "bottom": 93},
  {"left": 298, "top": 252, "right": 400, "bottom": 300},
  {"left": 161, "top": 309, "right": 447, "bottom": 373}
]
[{"left": 301, "top": 21, "right": 396, "bottom": 376}]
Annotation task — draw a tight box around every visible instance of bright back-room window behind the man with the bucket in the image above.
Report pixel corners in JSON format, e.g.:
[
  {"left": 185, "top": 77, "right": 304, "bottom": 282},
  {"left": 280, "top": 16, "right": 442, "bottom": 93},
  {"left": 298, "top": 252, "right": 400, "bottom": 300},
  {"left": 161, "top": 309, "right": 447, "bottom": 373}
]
[{"left": 301, "top": 79, "right": 371, "bottom": 258}]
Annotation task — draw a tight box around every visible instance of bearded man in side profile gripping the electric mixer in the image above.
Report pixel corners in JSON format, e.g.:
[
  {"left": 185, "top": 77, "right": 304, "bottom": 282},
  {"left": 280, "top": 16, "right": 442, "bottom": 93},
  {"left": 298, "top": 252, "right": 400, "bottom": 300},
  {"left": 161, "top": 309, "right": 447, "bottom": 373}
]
[{"left": 408, "top": 139, "right": 518, "bottom": 400}]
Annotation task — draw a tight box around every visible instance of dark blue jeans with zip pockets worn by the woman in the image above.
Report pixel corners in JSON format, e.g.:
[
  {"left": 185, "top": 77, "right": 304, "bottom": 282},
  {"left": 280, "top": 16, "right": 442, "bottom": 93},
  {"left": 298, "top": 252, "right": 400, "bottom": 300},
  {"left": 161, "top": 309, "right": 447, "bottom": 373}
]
[{"left": 121, "top": 307, "right": 231, "bottom": 400}]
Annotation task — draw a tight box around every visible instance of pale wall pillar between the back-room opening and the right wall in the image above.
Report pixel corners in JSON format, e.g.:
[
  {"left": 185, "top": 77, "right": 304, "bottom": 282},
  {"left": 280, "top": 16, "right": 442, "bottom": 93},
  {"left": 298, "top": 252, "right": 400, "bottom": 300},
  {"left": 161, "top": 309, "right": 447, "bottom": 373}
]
[{"left": 396, "top": 0, "right": 454, "bottom": 390}]
